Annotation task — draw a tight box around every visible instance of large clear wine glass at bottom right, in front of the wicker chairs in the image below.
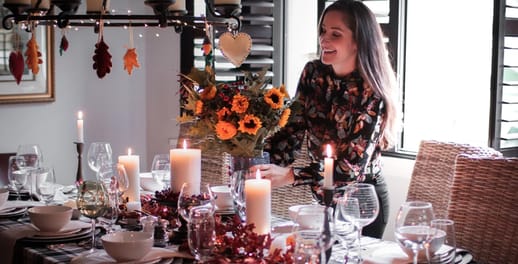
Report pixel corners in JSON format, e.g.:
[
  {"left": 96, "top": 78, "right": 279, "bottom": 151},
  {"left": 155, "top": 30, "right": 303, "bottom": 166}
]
[{"left": 395, "top": 201, "right": 434, "bottom": 264}]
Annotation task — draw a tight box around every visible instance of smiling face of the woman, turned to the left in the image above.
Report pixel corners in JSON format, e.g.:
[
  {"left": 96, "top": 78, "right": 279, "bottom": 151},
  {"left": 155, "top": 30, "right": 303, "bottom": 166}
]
[{"left": 319, "top": 11, "right": 357, "bottom": 76}]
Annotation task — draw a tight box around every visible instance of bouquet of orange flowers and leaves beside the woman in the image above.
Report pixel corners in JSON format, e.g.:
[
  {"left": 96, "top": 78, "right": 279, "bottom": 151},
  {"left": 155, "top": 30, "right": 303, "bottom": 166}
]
[{"left": 178, "top": 66, "right": 291, "bottom": 157}]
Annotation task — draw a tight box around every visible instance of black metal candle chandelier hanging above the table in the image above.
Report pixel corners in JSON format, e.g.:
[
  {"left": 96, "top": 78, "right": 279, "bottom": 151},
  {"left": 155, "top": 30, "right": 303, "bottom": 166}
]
[{"left": 2, "top": 0, "right": 241, "bottom": 33}]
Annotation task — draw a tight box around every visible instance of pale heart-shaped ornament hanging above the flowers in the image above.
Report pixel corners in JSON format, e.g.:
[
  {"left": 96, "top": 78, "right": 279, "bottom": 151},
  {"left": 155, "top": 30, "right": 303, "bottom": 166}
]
[{"left": 219, "top": 32, "right": 252, "bottom": 67}]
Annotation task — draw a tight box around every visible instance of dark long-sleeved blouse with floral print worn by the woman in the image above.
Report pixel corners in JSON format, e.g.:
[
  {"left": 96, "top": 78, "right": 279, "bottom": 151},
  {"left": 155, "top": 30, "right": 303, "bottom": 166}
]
[{"left": 265, "top": 60, "right": 384, "bottom": 198}]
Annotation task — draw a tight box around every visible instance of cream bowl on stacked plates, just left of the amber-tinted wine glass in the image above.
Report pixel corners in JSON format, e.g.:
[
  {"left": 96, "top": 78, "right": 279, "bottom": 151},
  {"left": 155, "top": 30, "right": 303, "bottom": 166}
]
[{"left": 28, "top": 205, "right": 73, "bottom": 232}]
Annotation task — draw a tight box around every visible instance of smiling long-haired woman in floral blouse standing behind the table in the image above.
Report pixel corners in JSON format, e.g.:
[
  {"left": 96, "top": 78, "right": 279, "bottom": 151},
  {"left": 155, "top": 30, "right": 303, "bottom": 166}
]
[{"left": 258, "top": 0, "right": 396, "bottom": 238}]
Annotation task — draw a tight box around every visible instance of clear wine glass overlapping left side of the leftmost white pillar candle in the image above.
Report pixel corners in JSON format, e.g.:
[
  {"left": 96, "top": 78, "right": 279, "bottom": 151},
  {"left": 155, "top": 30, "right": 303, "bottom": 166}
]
[{"left": 98, "top": 163, "right": 129, "bottom": 232}]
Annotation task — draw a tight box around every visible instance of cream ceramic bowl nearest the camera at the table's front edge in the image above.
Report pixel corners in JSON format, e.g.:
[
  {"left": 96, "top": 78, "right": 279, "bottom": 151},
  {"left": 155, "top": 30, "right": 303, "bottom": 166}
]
[{"left": 101, "top": 231, "right": 153, "bottom": 262}]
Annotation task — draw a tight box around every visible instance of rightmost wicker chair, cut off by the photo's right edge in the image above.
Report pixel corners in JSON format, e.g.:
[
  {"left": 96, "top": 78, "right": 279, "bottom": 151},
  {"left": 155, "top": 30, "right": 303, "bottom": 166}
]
[{"left": 448, "top": 154, "right": 518, "bottom": 263}]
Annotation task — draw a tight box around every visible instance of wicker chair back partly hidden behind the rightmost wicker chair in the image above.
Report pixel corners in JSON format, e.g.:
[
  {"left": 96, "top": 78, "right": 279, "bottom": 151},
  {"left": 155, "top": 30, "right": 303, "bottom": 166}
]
[{"left": 407, "top": 140, "right": 502, "bottom": 218}]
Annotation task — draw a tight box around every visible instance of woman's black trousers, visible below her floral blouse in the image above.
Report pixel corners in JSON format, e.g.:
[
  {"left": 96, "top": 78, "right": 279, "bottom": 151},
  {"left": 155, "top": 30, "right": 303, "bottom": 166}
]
[{"left": 362, "top": 175, "right": 389, "bottom": 238}]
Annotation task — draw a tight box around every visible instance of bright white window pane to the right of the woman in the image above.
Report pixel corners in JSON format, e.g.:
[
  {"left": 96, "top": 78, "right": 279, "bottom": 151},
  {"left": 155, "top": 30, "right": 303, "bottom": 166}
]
[{"left": 400, "top": 0, "right": 493, "bottom": 151}]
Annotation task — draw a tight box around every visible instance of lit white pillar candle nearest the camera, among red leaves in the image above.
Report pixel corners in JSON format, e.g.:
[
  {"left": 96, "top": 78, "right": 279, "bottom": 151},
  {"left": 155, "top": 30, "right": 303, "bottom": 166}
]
[{"left": 245, "top": 170, "right": 272, "bottom": 235}]
